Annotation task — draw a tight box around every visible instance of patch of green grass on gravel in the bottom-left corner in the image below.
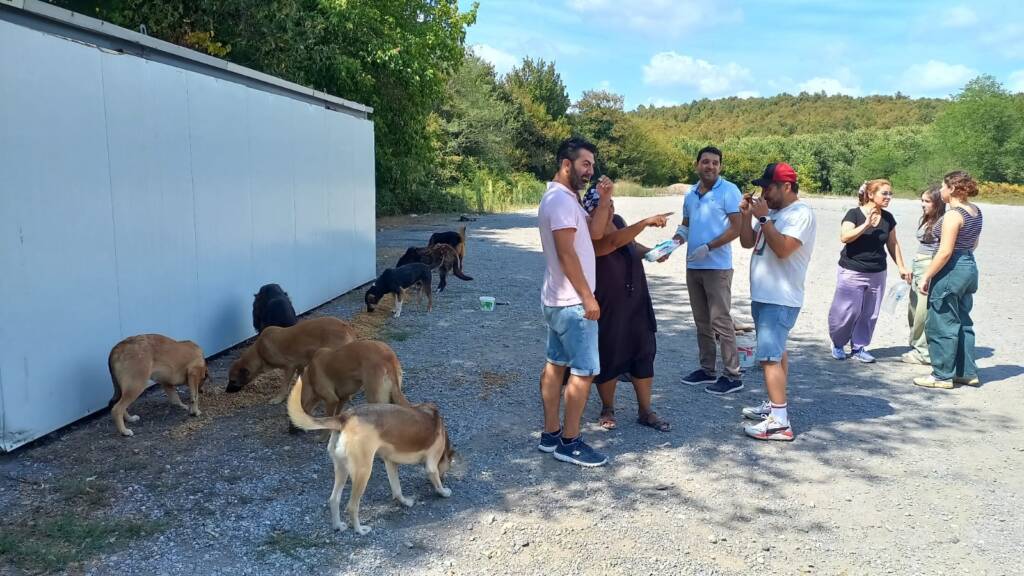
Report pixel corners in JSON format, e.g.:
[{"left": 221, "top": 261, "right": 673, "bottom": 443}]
[{"left": 0, "top": 515, "right": 165, "bottom": 572}]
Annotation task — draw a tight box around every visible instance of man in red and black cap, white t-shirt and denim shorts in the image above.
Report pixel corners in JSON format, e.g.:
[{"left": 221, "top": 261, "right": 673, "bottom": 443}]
[{"left": 739, "top": 162, "right": 816, "bottom": 441}]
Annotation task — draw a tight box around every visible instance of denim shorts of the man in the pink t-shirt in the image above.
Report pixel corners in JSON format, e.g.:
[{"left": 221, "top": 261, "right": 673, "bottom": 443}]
[{"left": 542, "top": 304, "right": 601, "bottom": 376}]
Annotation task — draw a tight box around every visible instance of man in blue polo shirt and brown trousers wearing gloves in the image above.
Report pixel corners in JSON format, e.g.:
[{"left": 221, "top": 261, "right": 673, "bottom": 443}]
[{"left": 675, "top": 146, "right": 743, "bottom": 395}]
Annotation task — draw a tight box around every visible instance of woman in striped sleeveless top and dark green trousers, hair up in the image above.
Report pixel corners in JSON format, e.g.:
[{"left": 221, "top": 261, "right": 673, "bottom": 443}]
[{"left": 913, "top": 171, "right": 982, "bottom": 388}]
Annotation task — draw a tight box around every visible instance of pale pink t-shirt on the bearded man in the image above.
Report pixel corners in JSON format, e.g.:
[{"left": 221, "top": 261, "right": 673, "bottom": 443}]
[{"left": 537, "top": 182, "right": 597, "bottom": 306}]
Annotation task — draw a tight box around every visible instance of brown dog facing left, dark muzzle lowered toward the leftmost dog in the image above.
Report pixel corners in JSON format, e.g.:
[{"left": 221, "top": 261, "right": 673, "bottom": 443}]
[{"left": 224, "top": 317, "right": 355, "bottom": 404}]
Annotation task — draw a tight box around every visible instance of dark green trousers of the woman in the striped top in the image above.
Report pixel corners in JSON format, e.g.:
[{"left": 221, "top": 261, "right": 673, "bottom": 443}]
[{"left": 925, "top": 251, "right": 978, "bottom": 380}]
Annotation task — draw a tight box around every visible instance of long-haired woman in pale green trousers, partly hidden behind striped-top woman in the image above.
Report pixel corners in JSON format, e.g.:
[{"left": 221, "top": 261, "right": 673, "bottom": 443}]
[{"left": 900, "top": 186, "right": 946, "bottom": 366}]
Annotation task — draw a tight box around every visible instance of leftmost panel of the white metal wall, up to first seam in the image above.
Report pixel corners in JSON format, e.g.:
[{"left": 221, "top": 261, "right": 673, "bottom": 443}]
[{"left": 0, "top": 23, "right": 120, "bottom": 446}]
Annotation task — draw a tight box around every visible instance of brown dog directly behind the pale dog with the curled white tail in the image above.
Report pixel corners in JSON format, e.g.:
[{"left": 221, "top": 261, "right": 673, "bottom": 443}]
[{"left": 302, "top": 340, "right": 409, "bottom": 416}]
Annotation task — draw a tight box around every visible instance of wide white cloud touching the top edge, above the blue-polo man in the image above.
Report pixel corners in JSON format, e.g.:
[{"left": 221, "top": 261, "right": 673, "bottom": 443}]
[{"left": 566, "top": 0, "right": 743, "bottom": 36}]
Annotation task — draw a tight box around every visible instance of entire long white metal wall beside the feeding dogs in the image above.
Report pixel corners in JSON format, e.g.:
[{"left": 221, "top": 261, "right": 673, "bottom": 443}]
[{"left": 0, "top": 14, "right": 375, "bottom": 450}]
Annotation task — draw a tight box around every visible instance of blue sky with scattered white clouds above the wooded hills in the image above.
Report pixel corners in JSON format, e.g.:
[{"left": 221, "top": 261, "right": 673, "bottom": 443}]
[{"left": 460, "top": 0, "right": 1024, "bottom": 109}]
